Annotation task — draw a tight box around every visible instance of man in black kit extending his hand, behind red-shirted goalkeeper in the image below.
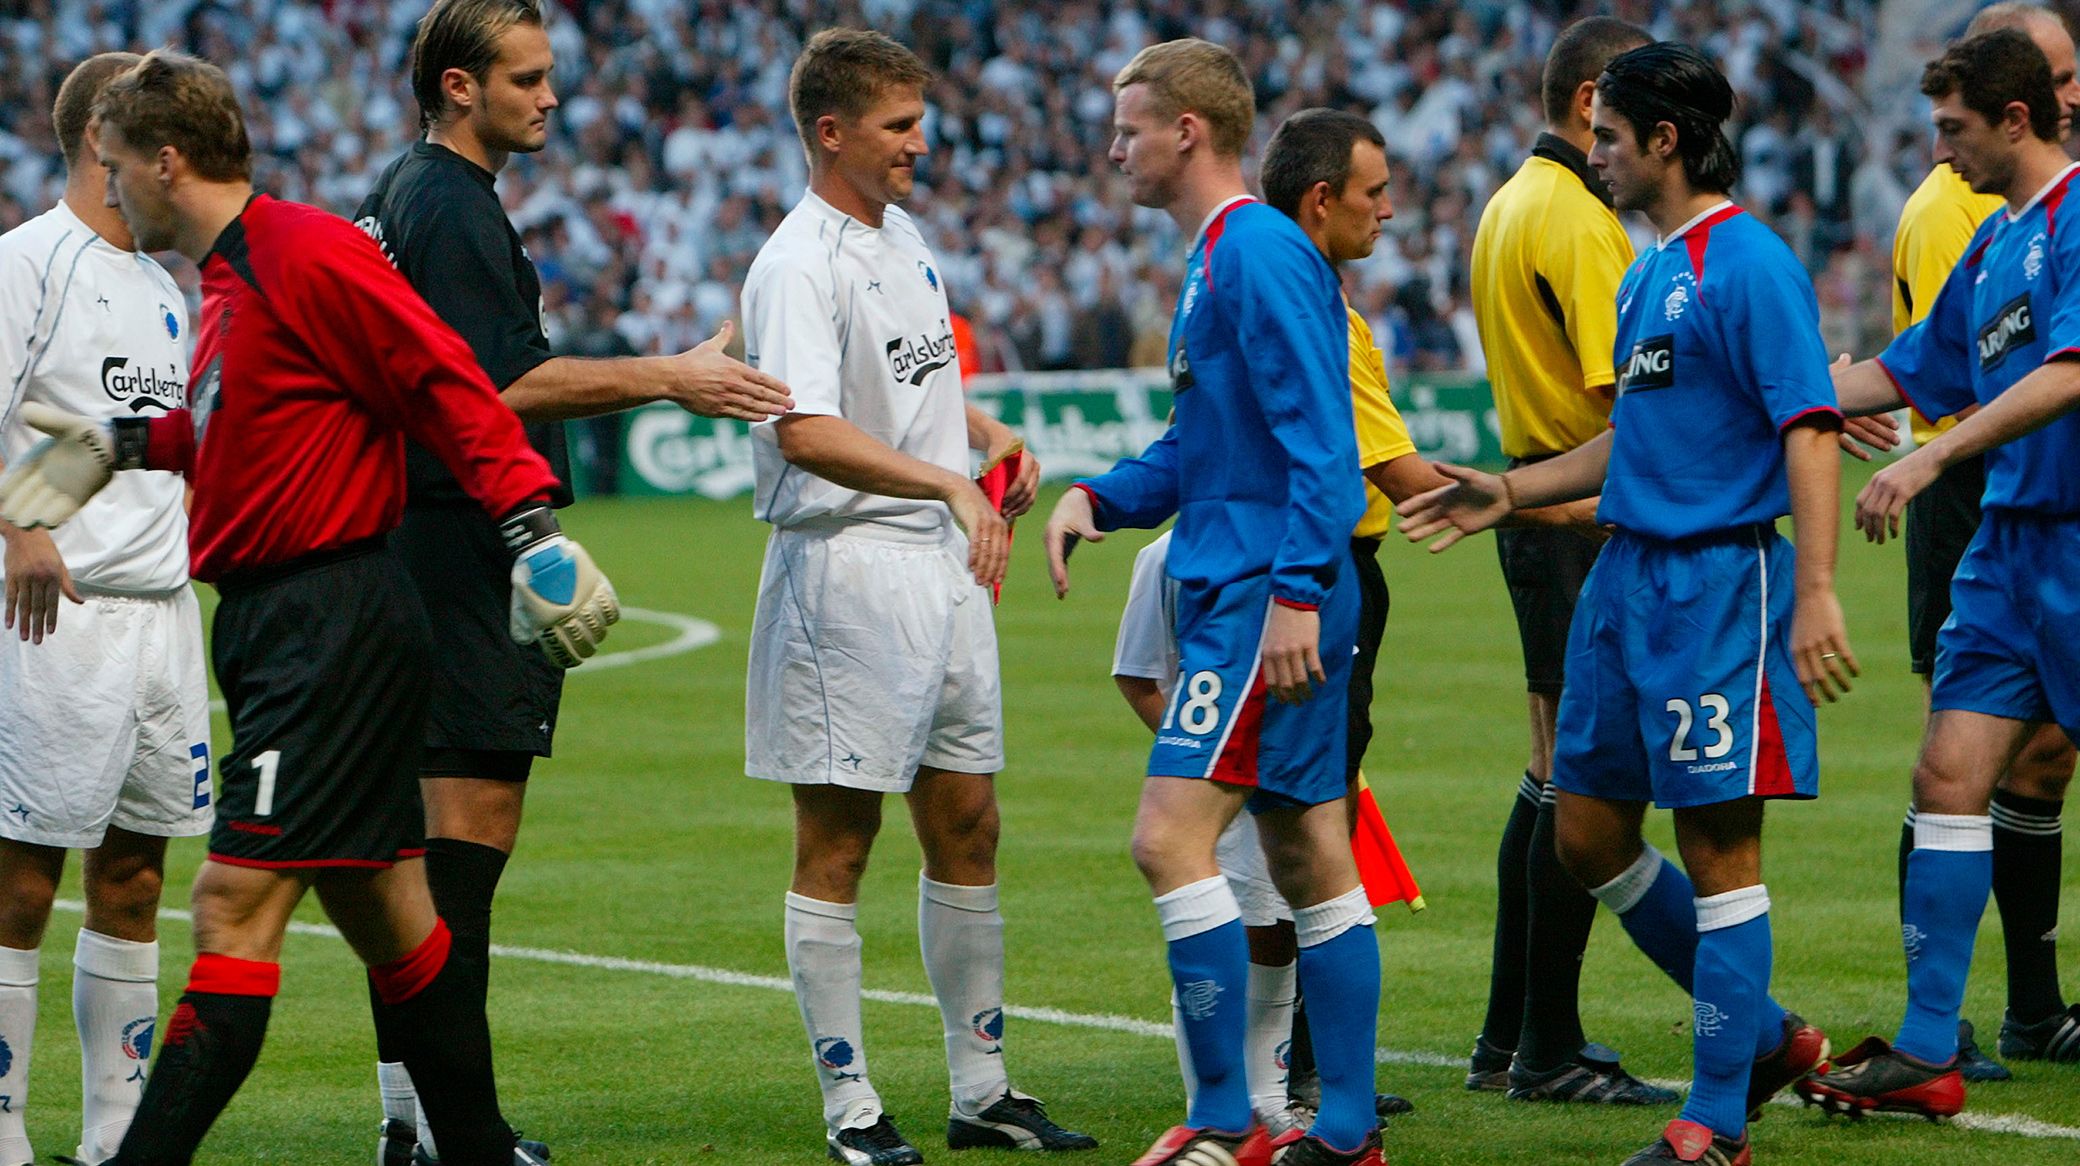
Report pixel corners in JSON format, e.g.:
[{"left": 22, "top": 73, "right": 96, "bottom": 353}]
[{"left": 356, "top": 0, "right": 790, "bottom": 1166}]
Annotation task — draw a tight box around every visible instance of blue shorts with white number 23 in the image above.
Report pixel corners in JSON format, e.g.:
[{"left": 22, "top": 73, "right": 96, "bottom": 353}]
[{"left": 1554, "top": 528, "right": 1820, "bottom": 809}]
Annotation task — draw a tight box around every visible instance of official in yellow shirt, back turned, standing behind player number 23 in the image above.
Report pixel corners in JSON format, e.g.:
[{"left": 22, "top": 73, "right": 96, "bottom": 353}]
[{"left": 1466, "top": 17, "right": 1674, "bottom": 1104}]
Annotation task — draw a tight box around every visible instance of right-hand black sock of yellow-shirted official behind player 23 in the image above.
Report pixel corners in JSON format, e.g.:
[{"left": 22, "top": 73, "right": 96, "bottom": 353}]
[{"left": 1516, "top": 786, "right": 1595, "bottom": 1070}]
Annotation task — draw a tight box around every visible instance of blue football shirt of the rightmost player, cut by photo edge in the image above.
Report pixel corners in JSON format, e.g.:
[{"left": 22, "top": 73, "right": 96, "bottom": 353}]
[{"left": 1878, "top": 164, "right": 2080, "bottom": 515}]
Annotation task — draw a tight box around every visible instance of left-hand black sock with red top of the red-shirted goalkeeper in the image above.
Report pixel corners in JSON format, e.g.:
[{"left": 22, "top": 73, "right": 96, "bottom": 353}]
[{"left": 108, "top": 954, "right": 281, "bottom": 1166}]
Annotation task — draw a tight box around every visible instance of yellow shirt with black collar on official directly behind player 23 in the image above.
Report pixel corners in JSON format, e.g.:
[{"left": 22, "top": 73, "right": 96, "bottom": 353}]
[{"left": 1473, "top": 133, "right": 1633, "bottom": 457}]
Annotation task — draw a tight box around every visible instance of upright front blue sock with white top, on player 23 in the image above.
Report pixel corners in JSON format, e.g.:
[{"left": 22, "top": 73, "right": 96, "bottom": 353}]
[{"left": 1683, "top": 883, "right": 1783, "bottom": 1139}]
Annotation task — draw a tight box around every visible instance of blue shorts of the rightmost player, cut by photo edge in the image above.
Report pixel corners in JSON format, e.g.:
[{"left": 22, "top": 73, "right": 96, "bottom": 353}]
[{"left": 1928, "top": 509, "right": 2080, "bottom": 740}]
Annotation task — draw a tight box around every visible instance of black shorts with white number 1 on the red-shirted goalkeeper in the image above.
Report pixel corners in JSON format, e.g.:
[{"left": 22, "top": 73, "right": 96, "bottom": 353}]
[{"left": 210, "top": 538, "right": 431, "bottom": 869}]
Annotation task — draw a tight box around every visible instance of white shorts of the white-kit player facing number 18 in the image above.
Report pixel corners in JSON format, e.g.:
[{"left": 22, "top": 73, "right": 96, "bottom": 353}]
[{"left": 745, "top": 524, "right": 1005, "bottom": 794}]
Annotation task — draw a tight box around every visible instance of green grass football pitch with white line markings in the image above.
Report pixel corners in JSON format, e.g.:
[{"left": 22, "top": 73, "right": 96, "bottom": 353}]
[{"left": 12, "top": 472, "right": 2080, "bottom": 1166}]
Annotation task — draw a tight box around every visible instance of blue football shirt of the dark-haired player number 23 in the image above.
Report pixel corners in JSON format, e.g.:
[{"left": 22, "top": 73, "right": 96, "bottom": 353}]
[{"left": 1595, "top": 204, "right": 1841, "bottom": 538}]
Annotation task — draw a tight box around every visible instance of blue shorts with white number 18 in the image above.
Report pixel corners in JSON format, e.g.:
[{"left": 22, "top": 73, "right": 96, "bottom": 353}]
[{"left": 1148, "top": 553, "right": 1358, "bottom": 811}]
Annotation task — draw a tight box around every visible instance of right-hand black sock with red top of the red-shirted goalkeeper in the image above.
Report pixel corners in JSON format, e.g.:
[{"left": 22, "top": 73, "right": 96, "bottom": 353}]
[{"left": 368, "top": 923, "right": 514, "bottom": 1166}]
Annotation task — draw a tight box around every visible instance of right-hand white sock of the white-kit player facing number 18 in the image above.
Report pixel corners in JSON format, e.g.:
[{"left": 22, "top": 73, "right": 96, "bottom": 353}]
[{"left": 917, "top": 875, "right": 1011, "bottom": 1116}]
